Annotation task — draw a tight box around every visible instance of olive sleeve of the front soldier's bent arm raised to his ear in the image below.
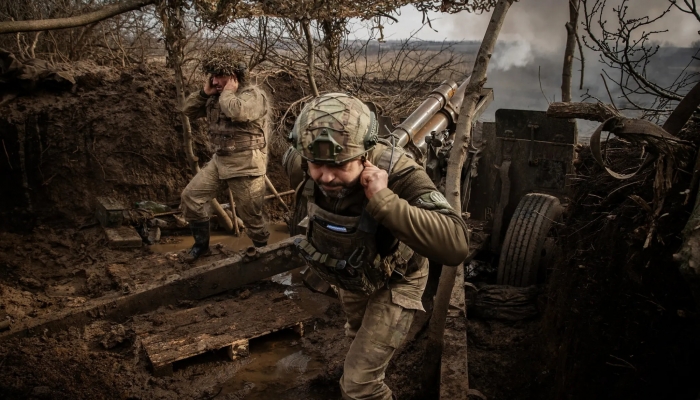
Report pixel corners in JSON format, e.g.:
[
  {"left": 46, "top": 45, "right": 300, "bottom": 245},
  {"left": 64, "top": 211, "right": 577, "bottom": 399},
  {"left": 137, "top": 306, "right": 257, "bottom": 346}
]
[{"left": 367, "top": 161, "right": 469, "bottom": 265}]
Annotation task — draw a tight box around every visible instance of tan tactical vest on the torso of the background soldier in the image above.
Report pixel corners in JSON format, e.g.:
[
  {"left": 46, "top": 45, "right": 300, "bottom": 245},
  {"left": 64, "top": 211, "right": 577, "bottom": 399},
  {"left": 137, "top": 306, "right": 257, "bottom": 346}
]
[{"left": 207, "top": 87, "right": 267, "bottom": 156}]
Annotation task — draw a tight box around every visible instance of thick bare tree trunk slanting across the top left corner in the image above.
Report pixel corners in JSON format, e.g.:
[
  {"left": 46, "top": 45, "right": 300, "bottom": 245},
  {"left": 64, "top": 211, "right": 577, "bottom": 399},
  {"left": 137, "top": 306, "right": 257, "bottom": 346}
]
[{"left": 0, "top": 0, "right": 156, "bottom": 34}]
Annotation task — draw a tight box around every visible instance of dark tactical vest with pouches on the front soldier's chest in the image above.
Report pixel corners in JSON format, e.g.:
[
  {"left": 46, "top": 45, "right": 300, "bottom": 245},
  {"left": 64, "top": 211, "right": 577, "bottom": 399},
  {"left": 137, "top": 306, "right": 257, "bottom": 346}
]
[{"left": 295, "top": 143, "right": 413, "bottom": 295}]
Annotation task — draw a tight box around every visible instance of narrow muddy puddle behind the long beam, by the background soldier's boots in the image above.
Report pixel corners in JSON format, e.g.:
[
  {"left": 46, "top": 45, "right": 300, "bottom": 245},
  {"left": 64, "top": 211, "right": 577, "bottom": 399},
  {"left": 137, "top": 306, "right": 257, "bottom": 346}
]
[{"left": 151, "top": 223, "right": 289, "bottom": 253}]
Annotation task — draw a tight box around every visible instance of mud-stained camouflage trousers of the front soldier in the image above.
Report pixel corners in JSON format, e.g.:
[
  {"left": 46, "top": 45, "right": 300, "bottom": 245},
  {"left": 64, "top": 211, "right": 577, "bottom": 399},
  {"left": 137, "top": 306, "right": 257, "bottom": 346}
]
[{"left": 339, "top": 259, "right": 428, "bottom": 400}]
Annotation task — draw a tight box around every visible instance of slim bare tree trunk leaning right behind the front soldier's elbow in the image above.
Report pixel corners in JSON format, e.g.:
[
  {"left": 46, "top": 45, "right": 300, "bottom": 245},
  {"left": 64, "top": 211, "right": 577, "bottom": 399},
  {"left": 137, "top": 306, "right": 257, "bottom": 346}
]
[{"left": 423, "top": 0, "right": 513, "bottom": 396}]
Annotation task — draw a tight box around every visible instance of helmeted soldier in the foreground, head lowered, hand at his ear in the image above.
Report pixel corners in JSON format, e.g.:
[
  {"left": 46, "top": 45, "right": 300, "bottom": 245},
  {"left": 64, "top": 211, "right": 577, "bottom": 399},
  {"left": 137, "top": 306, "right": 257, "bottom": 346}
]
[{"left": 286, "top": 93, "right": 469, "bottom": 400}]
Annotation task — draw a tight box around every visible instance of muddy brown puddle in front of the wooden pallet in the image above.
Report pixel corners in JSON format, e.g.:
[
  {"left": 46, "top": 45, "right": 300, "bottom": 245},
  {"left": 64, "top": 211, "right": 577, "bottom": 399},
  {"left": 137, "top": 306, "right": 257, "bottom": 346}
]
[{"left": 217, "top": 331, "right": 324, "bottom": 400}]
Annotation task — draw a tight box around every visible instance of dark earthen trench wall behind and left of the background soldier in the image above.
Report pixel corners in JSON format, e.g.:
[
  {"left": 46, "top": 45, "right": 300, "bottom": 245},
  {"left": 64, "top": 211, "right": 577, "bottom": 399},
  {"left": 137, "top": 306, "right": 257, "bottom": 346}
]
[{"left": 0, "top": 64, "right": 301, "bottom": 232}]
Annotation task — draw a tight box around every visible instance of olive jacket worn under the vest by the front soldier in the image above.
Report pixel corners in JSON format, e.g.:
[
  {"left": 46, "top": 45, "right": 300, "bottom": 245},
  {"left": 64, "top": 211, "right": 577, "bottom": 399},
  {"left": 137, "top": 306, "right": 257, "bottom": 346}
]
[{"left": 287, "top": 143, "right": 469, "bottom": 310}]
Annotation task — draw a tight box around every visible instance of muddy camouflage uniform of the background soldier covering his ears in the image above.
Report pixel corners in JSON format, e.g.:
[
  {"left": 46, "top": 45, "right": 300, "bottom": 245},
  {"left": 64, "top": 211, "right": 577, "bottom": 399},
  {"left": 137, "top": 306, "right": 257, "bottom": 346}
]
[{"left": 181, "top": 50, "right": 270, "bottom": 243}]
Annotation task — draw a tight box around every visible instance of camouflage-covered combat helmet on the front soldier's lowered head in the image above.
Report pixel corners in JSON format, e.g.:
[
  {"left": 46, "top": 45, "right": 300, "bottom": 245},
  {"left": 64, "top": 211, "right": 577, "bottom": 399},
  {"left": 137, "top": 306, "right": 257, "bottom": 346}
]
[{"left": 289, "top": 93, "right": 378, "bottom": 164}]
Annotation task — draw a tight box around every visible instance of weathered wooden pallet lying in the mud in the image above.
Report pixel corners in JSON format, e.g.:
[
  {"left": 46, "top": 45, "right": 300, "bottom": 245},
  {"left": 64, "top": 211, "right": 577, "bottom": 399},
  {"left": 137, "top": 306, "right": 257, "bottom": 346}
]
[{"left": 137, "top": 293, "right": 311, "bottom": 376}]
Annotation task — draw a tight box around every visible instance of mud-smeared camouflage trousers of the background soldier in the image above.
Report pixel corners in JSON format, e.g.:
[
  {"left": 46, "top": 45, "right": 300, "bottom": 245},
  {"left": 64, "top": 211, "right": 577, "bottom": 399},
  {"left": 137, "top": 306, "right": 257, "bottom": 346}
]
[{"left": 180, "top": 159, "right": 270, "bottom": 242}]
